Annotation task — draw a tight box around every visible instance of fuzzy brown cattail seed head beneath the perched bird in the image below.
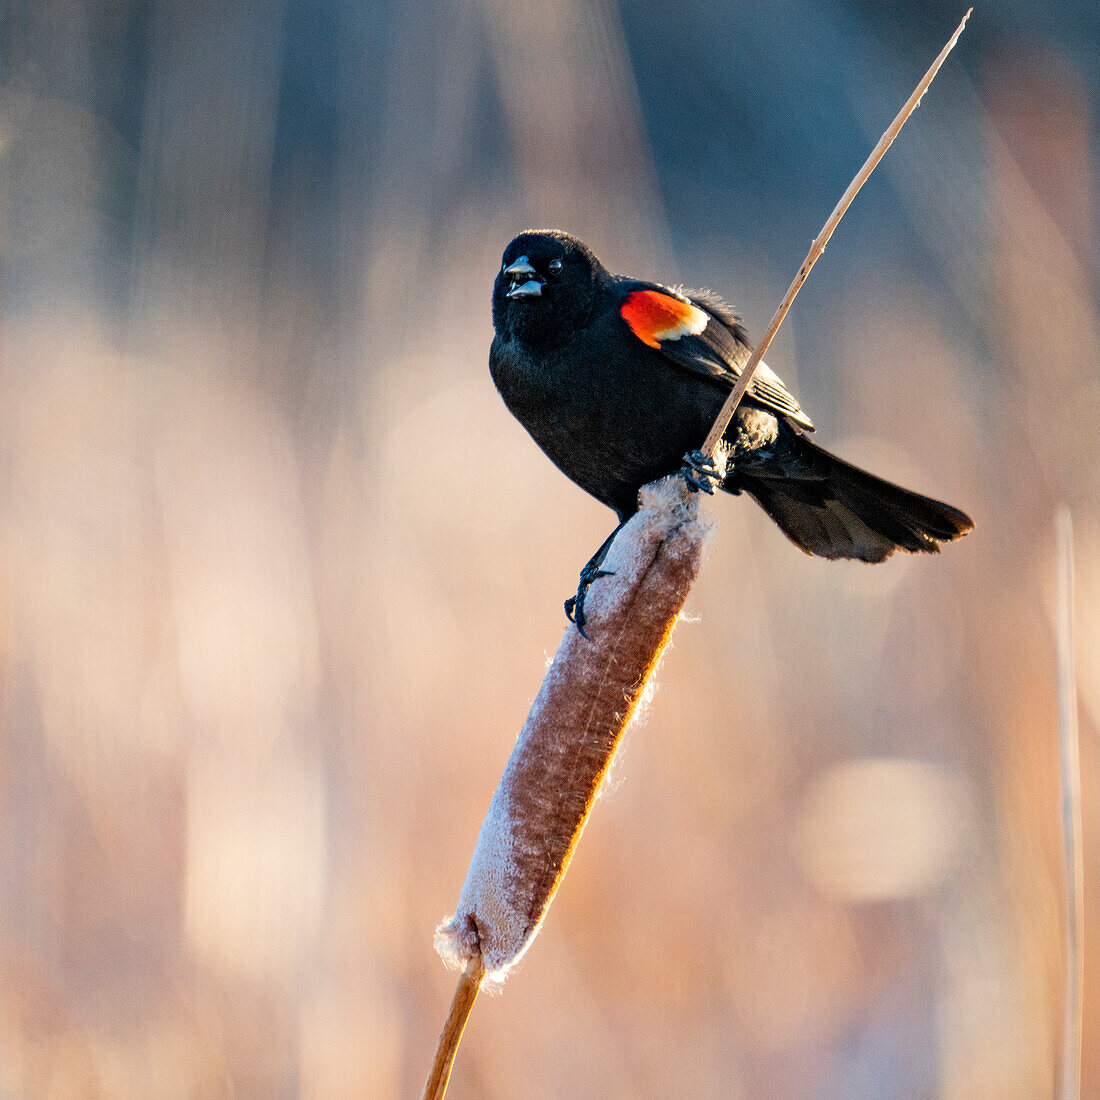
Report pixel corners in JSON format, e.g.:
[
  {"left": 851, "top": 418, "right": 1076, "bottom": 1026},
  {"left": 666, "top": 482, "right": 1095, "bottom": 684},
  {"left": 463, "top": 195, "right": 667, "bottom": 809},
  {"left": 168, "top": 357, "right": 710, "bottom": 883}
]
[{"left": 436, "top": 476, "right": 707, "bottom": 982}]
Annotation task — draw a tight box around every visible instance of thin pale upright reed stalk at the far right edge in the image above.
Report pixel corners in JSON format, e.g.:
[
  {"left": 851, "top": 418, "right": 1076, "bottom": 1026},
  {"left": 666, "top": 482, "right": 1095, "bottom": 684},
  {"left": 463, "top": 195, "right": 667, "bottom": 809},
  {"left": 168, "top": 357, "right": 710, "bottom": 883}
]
[{"left": 1055, "top": 505, "right": 1085, "bottom": 1100}]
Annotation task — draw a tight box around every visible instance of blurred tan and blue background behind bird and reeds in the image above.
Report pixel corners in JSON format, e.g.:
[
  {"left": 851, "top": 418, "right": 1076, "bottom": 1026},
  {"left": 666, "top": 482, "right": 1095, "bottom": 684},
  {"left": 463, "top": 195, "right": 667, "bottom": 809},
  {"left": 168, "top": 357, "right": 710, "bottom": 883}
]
[{"left": 0, "top": 0, "right": 1100, "bottom": 1100}]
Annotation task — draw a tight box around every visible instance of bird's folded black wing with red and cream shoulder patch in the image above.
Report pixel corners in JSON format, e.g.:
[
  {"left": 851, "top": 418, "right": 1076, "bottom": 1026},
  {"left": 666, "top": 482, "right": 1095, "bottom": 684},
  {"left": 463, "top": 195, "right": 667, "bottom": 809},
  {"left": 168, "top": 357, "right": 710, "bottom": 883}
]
[{"left": 619, "top": 284, "right": 814, "bottom": 431}]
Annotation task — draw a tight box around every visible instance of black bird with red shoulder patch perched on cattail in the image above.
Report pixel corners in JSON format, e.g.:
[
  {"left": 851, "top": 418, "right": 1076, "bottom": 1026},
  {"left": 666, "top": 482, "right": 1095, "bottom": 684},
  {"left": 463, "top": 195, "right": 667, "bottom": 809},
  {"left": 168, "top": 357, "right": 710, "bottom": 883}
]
[{"left": 490, "top": 230, "right": 974, "bottom": 633}]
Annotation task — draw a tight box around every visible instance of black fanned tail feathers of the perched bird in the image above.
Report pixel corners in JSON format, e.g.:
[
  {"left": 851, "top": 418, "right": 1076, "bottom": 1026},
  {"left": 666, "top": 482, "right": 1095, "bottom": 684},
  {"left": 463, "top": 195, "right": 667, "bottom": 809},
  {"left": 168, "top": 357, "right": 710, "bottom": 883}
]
[{"left": 726, "top": 436, "right": 974, "bottom": 562}]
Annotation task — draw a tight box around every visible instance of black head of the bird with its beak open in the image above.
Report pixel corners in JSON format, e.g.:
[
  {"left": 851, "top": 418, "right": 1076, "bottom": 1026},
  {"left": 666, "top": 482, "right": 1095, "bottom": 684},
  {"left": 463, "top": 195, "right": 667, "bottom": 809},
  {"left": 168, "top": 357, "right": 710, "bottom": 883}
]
[{"left": 493, "top": 230, "right": 608, "bottom": 344}]
